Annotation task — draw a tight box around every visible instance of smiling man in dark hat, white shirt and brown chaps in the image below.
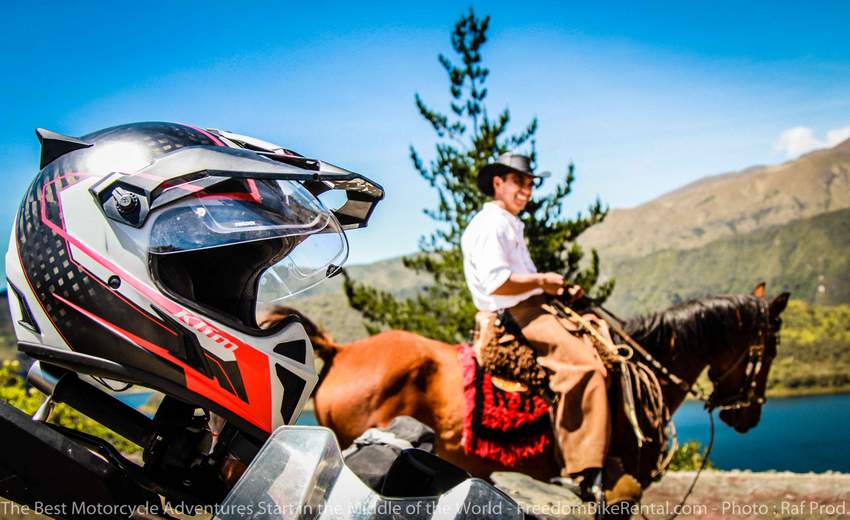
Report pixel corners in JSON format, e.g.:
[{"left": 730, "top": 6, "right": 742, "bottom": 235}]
[{"left": 461, "top": 153, "right": 611, "bottom": 496}]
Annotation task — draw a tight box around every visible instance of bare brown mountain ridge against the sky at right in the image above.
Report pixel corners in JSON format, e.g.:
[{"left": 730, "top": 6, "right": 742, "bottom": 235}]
[{"left": 579, "top": 139, "right": 850, "bottom": 260}]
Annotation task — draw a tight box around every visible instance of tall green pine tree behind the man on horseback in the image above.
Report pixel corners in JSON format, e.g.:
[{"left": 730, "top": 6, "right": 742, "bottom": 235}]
[{"left": 343, "top": 9, "right": 614, "bottom": 342}]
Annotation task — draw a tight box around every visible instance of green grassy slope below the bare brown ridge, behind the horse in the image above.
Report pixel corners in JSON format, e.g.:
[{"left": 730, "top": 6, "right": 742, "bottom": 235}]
[{"left": 602, "top": 209, "right": 850, "bottom": 316}]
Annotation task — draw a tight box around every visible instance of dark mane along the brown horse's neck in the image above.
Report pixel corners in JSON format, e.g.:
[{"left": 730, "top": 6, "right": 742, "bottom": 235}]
[{"left": 624, "top": 295, "right": 760, "bottom": 358}]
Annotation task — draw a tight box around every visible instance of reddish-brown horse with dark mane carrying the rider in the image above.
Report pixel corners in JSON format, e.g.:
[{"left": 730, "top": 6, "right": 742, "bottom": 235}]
[{"left": 264, "top": 284, "right": 789, "bottom": 487}]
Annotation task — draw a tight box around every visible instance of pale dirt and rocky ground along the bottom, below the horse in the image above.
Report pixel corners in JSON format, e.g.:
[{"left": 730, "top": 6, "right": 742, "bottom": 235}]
[{"left": 493, "top": 471, "right": 850, "bottom": 520}]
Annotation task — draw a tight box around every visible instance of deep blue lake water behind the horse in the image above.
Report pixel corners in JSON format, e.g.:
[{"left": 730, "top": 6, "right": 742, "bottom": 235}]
[{"left": 298, "top": 394, "right": 850, "bottom": 473}]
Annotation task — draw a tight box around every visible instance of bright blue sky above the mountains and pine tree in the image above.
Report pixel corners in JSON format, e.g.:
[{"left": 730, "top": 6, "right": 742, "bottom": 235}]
[{"left": 0, "top": 0, "right": 850, "bottom": 263}]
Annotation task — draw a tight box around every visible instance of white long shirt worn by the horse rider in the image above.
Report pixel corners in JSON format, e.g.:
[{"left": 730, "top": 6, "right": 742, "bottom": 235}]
[{"left": 460, "top": 202, "right": 543, "bottom": 311}]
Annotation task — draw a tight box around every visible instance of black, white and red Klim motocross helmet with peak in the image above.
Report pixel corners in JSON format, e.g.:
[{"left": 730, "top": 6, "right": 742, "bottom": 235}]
[{"left": 6, "top": 123, "right": 383, "bottom": 438}]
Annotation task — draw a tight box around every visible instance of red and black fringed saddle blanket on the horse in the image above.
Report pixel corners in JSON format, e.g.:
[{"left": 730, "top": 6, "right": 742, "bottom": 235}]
[{"left": 458, "top": 344, "right": 552, "bottom": 466}]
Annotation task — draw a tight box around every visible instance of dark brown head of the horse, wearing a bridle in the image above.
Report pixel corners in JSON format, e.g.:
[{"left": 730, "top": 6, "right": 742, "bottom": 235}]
[{"left": 707, "top": 283, "right": 789, "bottom": 433}]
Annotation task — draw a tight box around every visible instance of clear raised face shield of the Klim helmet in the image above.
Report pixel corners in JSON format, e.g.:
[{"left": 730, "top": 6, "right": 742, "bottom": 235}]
[{"left": 148, "top": 178, "right": 348, "bottom": 311}]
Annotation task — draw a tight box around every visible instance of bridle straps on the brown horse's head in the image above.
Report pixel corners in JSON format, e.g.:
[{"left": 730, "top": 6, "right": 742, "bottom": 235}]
[{"left": 702, "top": 299, "right": 779, "bottom": 411}]
